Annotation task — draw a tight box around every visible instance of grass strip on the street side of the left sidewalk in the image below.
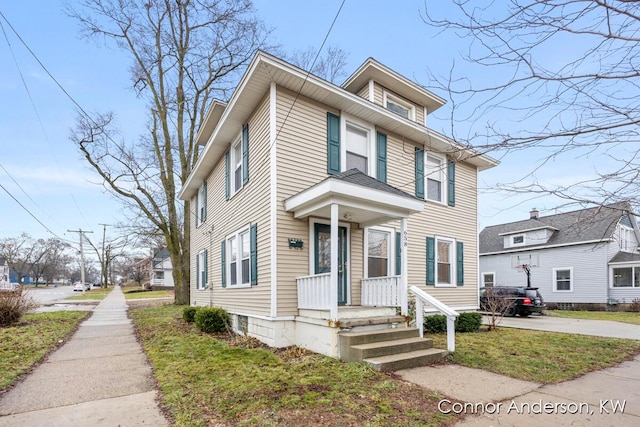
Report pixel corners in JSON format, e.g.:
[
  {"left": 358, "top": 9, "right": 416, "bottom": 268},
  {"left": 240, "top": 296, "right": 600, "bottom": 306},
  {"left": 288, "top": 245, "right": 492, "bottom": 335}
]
[{"left": 0, "top": 311, "right": 89, "bottom": 390}]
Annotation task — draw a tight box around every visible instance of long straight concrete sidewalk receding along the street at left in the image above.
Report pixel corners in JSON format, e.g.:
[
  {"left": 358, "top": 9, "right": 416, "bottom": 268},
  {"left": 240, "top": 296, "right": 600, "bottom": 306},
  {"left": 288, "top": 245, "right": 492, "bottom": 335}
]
[{"left": 0, "top": 287, "right": 169, "bottom": 427}]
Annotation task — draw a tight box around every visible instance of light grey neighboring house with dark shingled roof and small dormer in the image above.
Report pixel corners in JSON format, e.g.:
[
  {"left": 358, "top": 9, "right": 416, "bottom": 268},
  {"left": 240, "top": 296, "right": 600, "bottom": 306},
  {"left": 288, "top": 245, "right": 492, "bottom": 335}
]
[{"left": 480, "top": 203, "right": 640, "bottom": 309}]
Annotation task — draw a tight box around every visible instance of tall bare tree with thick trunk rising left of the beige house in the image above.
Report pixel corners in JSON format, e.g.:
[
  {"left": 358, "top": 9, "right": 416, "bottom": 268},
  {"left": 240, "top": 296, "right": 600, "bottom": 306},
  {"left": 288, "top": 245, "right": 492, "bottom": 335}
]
[{"left": 69, "top": 0, "right": 269, "bottom": 304}]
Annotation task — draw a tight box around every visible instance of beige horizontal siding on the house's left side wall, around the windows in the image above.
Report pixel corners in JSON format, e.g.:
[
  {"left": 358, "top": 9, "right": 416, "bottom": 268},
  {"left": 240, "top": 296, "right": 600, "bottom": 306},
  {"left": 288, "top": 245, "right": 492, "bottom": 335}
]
[{"left": 191, "top": 92, "right": 271, "bottom": 316}]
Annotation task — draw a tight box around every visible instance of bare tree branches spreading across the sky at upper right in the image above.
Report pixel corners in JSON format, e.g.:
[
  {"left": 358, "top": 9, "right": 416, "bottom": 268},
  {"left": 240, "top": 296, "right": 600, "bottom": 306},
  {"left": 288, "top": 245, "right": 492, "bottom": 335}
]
[{"left": 424, "top": 0, "right": 640, "bottom": 211}]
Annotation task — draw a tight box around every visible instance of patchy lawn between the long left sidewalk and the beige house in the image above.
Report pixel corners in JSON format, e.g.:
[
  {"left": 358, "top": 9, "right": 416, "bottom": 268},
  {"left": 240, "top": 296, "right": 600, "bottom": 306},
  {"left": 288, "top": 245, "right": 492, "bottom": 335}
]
[{"left": 130, "top": 305, "right": 457, "bottom": 426}]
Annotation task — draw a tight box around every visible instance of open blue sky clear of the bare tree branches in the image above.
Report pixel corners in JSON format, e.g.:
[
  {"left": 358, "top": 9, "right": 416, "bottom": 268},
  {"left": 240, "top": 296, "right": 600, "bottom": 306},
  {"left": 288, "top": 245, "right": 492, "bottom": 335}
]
[{"left": 0, "top": 0, "right": 589, "bottom": 241}]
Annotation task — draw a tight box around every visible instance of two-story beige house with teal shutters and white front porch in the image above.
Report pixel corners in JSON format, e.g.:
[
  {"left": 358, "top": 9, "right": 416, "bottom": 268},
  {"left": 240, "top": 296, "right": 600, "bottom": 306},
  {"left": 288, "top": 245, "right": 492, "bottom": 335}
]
[{"left": 180, "top": 52, "right": 497, "bottom": 364}]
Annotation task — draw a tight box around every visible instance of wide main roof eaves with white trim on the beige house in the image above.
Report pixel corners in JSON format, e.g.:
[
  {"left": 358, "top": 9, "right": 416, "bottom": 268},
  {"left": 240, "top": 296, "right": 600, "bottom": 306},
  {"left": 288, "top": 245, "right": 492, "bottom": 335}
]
[{"left": 178, "top": 51, "right": 498, "bottom": 200}]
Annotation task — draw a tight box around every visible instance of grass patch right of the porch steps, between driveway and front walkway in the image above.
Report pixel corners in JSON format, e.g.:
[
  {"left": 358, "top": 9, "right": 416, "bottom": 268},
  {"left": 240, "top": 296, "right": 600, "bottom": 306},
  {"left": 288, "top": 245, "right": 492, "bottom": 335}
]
[{"left": 429, "top": 328, "right": 640, "bottom": 384}]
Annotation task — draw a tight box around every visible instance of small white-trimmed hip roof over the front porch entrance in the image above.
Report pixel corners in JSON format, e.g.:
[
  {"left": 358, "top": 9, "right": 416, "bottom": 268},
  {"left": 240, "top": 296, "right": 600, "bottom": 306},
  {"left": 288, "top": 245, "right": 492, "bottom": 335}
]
[{"left": 284, "top": 169, "right": 424, "bottom": 226}]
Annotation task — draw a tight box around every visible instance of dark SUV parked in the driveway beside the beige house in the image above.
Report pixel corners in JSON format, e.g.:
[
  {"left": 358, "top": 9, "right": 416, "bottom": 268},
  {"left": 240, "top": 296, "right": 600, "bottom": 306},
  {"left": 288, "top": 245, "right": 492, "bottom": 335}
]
[{"left": 480, "top": 286, "right": 547, "bottom": 317}]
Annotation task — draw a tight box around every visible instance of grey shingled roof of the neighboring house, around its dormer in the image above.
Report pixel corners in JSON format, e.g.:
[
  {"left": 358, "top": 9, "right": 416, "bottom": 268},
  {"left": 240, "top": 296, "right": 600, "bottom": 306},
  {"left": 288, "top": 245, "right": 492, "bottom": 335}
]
[{"left": 479, "top": 202, "right": 631, "bottom": 255}]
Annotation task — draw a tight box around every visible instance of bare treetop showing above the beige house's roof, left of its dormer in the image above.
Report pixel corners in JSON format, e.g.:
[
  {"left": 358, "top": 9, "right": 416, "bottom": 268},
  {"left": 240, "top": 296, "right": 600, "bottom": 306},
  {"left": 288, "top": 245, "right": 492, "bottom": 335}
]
[{"left": 287, "top": 46, "right": 348, "bottom": 83}]
